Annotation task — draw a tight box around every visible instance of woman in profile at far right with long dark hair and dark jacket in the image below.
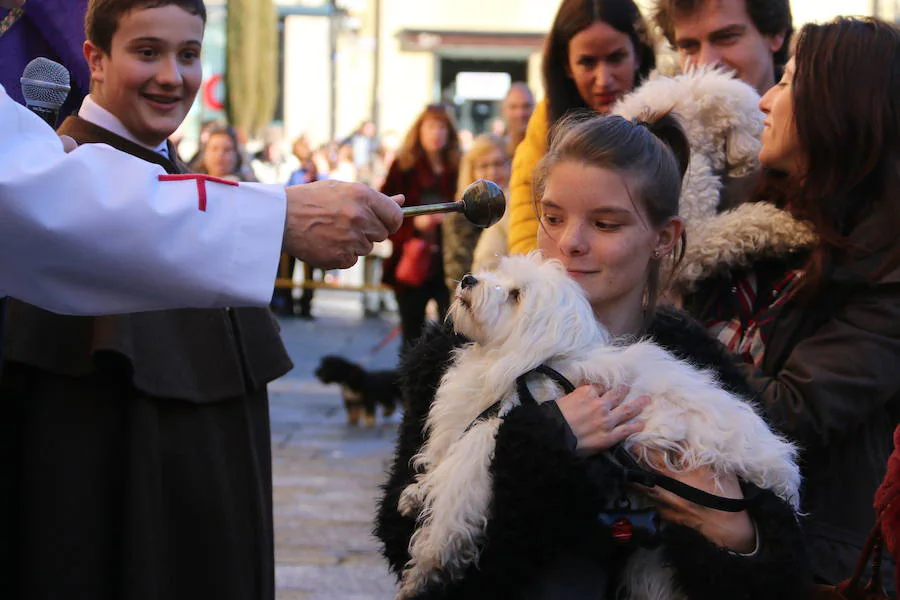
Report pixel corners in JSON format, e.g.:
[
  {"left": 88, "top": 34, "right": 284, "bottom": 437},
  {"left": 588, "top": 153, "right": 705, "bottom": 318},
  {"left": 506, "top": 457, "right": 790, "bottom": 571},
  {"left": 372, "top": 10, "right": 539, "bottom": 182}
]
[{"left": 688, "top": 18, "right": 900, "bottom": 588}]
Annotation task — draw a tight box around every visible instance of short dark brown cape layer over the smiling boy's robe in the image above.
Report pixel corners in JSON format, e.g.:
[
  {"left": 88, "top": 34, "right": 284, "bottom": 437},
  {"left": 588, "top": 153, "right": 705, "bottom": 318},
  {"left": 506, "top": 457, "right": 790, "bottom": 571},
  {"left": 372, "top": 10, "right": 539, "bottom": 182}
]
[{"left": 4, "top": 117, "right": 293, "bottom": 402}]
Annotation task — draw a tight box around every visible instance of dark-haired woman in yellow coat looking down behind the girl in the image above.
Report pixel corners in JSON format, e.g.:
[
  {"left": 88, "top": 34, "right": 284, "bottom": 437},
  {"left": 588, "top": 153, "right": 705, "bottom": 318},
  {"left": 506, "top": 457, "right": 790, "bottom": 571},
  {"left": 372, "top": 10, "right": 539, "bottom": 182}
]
[{"left": 508, "top": 0, "right": 656, "bottom": 253}]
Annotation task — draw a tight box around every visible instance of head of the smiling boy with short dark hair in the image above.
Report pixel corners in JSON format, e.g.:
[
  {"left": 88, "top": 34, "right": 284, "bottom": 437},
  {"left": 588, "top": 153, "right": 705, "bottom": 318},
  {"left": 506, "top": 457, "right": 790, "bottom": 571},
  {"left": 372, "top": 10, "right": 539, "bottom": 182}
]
[{"left": 84, "top": 4, "right": 204, "bottom": 146}]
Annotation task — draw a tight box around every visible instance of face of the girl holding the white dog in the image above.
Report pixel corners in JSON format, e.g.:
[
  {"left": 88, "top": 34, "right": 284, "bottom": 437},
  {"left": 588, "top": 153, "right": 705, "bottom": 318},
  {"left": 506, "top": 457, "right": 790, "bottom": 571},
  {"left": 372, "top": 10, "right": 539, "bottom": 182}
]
[{"left": 538, "top": 161, "right": 674, "bottom": 318}]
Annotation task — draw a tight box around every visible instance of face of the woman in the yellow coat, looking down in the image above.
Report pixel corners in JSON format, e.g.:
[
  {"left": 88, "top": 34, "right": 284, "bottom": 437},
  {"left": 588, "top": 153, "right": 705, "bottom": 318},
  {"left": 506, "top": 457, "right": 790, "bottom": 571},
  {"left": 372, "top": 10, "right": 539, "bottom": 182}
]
[{"left": 566, "top": 21, "right": 639, "bottom": 114}]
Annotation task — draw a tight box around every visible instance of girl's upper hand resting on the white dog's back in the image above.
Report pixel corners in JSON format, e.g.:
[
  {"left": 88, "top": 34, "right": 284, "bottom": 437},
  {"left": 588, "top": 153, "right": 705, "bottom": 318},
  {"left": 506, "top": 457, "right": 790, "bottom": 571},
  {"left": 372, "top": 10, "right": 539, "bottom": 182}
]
[{"left": 556, "top": 385, "right": 650, "bottom": 455}]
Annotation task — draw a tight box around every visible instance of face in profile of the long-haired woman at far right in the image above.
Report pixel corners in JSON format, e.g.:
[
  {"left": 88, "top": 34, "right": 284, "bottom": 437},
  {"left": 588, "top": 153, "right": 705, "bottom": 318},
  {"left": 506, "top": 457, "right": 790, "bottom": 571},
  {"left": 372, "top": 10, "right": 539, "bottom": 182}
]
[{"left": 759, "top": 58, "right": 806, "bottom": 177}]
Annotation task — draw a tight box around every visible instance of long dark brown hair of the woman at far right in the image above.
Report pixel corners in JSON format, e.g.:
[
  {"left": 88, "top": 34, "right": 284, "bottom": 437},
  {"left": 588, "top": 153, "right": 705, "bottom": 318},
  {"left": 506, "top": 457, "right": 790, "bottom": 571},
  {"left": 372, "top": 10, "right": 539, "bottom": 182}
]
[{"left": 789, "top": 17, "right": 900, "bottom": 297}]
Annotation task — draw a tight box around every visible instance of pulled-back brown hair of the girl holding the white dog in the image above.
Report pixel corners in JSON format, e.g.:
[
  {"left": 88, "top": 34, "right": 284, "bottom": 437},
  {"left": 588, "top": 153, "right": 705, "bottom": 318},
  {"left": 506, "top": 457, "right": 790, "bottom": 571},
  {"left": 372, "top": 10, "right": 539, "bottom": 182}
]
[{"left": 533, "top": 112, "right": 690, "bottom": 327}]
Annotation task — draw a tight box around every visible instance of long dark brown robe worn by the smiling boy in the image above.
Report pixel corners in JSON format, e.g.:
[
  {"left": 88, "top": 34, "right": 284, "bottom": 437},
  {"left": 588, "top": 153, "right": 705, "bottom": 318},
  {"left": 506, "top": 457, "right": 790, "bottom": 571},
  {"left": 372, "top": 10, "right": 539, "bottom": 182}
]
[{"left": 0, "top": 117, "right": 292, "bottom": 600}]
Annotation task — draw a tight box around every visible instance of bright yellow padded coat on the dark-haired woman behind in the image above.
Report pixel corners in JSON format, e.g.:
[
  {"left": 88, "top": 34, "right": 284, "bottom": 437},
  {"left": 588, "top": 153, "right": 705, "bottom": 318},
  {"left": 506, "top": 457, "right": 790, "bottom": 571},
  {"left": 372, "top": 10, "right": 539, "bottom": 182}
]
[{"left": 508, "top": 100, "right": 549, "bottom": 254}]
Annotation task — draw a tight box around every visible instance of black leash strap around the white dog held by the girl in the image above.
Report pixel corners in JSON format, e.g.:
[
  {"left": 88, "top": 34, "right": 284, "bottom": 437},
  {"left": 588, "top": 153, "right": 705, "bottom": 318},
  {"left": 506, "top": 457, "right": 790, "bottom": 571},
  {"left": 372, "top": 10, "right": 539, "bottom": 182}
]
[{"left": 506, "top": 365, "right": 759, "bottom": 512}]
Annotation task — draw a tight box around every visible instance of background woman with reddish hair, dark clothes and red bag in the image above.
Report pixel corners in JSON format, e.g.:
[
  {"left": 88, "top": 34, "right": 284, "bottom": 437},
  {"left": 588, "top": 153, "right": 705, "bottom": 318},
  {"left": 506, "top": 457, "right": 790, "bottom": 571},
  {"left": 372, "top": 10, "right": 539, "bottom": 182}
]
[{"left": 381, "top": 104, "right": 460, "bottom": 347}]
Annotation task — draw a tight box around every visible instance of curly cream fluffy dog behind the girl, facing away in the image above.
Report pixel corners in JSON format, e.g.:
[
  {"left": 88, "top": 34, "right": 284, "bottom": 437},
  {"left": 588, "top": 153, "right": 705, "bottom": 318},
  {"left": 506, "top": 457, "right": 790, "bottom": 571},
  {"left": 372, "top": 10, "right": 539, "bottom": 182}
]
[{"left": 612, "top": 67, "right": 816, "bottom": 294}]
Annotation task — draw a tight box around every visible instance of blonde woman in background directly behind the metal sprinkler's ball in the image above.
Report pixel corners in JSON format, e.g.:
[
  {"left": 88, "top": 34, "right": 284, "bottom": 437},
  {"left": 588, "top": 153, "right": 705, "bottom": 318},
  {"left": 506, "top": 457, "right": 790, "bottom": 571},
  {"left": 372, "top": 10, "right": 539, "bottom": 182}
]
[{"left": 442, "top": 134, "right": 509, "bottom": 294}]
